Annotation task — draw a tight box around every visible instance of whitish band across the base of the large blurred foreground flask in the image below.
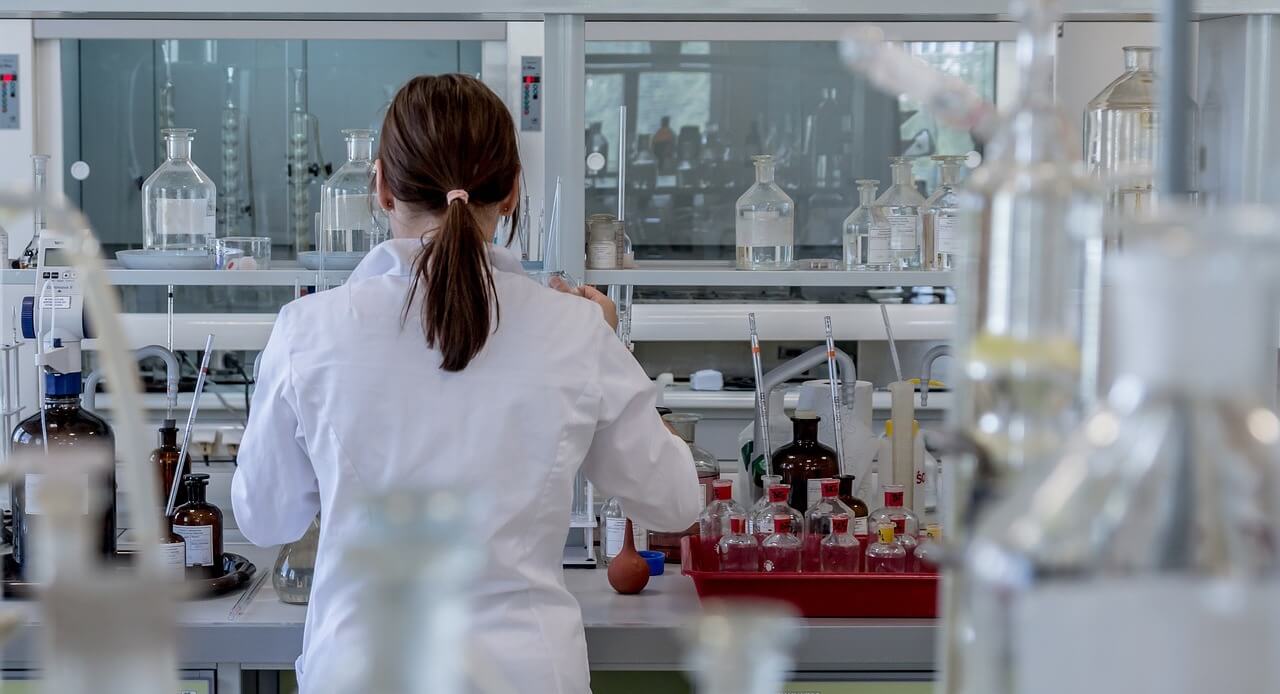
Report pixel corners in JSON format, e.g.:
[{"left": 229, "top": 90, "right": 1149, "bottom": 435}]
[{"left": 1009, "top": 576, "right": 1280, "bottom": 694}]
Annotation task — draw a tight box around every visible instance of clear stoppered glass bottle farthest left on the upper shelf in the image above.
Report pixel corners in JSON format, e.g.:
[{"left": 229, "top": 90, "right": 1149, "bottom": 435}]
[{"left": 142, "top": 128, "right": 218, "bottom": 251}]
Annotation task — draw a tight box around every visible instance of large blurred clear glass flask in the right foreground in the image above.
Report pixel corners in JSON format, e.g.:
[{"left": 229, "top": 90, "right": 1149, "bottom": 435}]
[{"left": 964, "top": 205, "right": 1280, "bottom": 694}]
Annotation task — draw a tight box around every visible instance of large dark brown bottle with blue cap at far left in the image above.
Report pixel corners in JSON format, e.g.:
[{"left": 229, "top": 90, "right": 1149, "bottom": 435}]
[{"left": 9, "top": 373, "right": 115, "bottom": 580}]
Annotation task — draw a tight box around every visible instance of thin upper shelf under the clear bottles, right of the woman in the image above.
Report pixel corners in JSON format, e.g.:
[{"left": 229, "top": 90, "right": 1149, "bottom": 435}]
[{"left": 586, "top": 260, "right": 955, "bottom": 287}]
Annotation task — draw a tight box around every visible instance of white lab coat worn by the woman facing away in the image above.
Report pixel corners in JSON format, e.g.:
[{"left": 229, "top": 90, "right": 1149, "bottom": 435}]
[{"left": 232, "top": 239, "right": 701, "bottom": 694}]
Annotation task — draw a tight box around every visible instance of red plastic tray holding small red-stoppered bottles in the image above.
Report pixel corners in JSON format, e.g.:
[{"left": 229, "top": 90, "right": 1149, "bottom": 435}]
[{"left": 680, "top": 537, "right": 938, "bottom": 618}]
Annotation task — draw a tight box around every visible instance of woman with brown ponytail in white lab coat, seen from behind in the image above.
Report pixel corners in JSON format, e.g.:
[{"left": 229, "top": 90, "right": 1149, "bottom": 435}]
[{"left": 232, "top": 74, "right": 701, "bottom": 694}]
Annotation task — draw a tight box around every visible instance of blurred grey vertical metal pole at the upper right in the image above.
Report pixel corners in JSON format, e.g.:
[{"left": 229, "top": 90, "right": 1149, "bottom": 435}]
[{"left": 1156, "top": 0, "right": 1192, "bottom": 197}]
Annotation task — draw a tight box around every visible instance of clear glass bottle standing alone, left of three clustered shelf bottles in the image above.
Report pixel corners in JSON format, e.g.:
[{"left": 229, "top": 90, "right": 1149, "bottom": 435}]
[{"left": 735, "top": 155, "right": 795, "bottom": 270}]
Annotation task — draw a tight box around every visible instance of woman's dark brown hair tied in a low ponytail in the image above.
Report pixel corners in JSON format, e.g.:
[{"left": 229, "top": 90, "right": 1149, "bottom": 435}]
[{"left": 378, "top": 74, "right": 520, "bottom": 371}]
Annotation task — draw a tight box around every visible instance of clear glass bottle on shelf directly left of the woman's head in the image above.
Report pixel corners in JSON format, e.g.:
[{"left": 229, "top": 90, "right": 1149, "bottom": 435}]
[{"left": 317, "top": 131, "right": 387, "bottom": 254}]
